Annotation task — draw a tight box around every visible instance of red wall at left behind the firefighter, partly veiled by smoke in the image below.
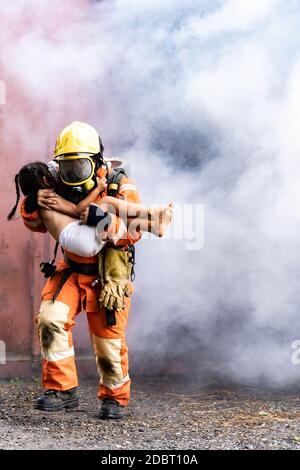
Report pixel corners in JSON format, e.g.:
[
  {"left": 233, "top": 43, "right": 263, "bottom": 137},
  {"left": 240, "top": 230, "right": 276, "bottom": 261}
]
[{"left": 0, "top": 0, "right": 103, "bottom": 378}]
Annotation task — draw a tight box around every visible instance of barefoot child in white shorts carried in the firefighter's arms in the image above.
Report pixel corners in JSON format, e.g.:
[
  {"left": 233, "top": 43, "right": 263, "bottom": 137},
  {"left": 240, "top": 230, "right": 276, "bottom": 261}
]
[{"left": 8, "top": 162, "right": 173, "bottom": 257}]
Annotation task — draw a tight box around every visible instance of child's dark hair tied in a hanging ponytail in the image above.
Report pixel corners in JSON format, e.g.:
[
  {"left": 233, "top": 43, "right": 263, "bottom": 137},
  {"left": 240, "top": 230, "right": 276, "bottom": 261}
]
[{"left": 7, "top": 162, "right": 55, "bottom": 220}]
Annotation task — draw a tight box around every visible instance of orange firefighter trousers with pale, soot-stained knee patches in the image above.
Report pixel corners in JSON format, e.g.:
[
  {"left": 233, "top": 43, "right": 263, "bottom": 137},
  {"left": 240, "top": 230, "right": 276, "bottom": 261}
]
[{"left": 37, "top": 261, "right": 130, "bottom": 406}]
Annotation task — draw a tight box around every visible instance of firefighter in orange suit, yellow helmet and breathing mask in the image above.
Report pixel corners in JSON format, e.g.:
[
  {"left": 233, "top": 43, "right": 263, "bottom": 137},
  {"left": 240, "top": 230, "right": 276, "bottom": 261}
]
[{"left": 21, "top": 122, "right": 140, "bottom": 419}]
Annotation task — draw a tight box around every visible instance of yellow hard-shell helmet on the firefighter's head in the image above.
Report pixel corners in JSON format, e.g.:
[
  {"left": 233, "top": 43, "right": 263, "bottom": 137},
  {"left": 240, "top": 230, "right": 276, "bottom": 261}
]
[{"left": 54, "top": 121, "right": 101, "bottom": 160}]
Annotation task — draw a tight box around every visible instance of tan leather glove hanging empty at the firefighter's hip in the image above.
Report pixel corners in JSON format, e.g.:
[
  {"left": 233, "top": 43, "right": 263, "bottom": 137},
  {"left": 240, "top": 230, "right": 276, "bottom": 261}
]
[{"left": 99, "top": 247, "right": 131, "bottom": 310}]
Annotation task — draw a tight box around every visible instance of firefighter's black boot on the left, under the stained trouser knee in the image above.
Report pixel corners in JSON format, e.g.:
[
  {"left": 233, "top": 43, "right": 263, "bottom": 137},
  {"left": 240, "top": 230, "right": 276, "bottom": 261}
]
[{"left": 34, "top": 387, "right": 79, "bottom": 411}]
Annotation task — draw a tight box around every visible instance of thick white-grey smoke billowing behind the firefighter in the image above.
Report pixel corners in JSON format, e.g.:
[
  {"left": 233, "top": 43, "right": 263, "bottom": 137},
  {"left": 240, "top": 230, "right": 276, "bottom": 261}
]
[{"left": 0, "top": 0, "right": 300, "bottom": 385}]
